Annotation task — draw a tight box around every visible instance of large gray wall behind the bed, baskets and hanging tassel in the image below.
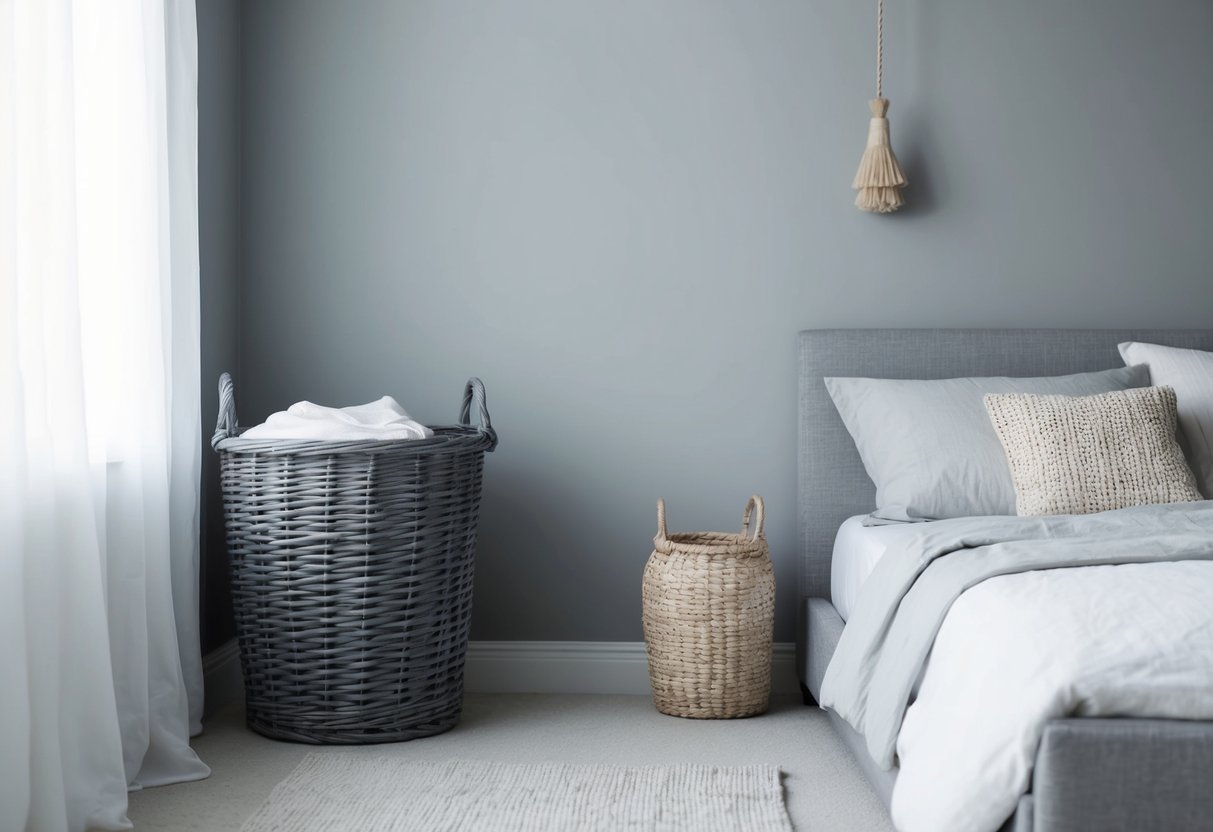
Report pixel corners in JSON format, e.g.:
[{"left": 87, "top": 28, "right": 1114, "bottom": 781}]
[{"left": 238, "top": 0, "right": 1213, "bottom": 640}]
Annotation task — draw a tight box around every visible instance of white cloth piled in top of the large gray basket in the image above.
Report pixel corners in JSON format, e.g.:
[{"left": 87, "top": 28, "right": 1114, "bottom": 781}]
[{"left": 241, "top": 395, "right": 434, "bottom": 441}]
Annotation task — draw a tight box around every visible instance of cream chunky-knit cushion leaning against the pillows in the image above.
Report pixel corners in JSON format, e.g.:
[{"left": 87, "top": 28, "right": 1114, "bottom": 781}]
[{"left": 985, "top": 387, "right": 1201, "bottom": 515}]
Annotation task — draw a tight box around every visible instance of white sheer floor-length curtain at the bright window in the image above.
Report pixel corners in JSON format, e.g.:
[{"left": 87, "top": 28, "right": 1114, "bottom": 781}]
[{"left": 0, "top": 0, "right": 209, "bottom": 832}]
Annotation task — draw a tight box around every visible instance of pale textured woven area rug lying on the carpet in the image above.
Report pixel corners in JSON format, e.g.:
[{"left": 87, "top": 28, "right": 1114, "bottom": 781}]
[{"left": 243, "top": 752, "right": 792, "bottom": 832}]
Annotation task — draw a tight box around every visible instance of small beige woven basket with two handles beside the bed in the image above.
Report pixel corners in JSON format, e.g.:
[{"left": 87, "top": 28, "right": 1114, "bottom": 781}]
[{"left": 642, "top": 495, "right": 775, "bottom": 719}]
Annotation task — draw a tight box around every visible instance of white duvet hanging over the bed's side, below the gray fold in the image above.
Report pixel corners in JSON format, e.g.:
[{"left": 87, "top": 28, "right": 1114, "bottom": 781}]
[{"left": 893, "top": 560, "right": 1213, "bottom": 832}]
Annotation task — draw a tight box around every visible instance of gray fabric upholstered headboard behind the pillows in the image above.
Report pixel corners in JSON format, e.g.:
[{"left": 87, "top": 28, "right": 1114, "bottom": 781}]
[{"left": 799, "top": 330, "right": 1213, "bottom": 598}]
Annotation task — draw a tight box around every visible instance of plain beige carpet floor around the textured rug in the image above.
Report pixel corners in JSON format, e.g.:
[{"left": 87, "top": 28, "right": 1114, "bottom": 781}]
[{"left": 130, "top": 694, "right": 892, "bottom": 832}]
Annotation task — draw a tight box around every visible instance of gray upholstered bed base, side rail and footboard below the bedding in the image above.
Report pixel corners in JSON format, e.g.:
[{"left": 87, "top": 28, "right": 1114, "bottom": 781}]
[{"left": 796, "top": 598, "right": 1213, "bottom": 832}]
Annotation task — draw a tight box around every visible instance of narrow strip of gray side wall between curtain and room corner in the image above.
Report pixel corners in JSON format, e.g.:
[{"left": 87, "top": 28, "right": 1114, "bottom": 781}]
[{"left": 198, "top": 0, "right": 241, "bottom": 653}]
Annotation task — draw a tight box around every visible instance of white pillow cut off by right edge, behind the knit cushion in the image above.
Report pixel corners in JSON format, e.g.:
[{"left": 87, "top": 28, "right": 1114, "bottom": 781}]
[{"left": 1121, "top": 341, "right": 1213, "bottom": 500}]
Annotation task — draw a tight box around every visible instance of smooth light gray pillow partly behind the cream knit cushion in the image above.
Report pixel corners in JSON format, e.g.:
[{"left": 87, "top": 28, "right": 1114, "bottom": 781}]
[{"left": 825, "top": 366, "right": 1150, "bottom": 523}]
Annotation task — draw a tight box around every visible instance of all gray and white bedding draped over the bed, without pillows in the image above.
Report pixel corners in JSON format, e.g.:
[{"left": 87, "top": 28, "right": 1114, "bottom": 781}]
[{"left": 820, "top": 501, "right": 1213, "bottom": 832}]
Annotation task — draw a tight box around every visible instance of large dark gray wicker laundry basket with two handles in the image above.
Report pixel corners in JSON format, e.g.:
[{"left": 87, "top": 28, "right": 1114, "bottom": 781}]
[{"left": 211, "top": 374, "right": 497, "bottom": 743}]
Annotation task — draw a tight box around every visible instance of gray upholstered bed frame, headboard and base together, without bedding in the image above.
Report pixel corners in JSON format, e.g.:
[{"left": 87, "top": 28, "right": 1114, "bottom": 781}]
[{"left": 797, "top": 330, "right": 1213, "bottom": 832}]
